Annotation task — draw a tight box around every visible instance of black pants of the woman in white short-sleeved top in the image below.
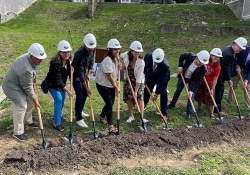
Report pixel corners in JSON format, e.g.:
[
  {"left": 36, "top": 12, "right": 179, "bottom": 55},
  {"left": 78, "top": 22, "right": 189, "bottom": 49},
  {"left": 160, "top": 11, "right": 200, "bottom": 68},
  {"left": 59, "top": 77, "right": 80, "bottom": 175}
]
[{"left": 96, "top": 83, "right": 115, "bottom": 125}]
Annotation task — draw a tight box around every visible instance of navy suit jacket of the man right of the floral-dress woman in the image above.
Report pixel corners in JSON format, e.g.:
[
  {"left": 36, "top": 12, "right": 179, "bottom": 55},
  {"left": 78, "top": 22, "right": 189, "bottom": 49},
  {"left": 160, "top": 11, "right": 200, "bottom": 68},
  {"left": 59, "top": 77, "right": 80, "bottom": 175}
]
[{"left": 144, "top": 52, "right": 170, "bottom": 94}]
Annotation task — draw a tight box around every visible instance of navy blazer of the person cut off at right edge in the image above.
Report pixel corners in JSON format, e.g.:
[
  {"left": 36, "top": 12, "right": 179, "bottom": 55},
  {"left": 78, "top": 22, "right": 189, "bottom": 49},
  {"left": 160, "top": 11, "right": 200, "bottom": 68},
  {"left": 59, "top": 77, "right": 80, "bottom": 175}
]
[{"left": 242, "top": 46, "right": 250, "bottom": 82}]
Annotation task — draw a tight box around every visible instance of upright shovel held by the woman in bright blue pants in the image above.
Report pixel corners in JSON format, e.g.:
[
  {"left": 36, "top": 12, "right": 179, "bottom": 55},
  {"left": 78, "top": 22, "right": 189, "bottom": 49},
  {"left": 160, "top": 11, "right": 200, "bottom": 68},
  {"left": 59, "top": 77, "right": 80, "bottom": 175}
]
[{"left": 64, "top": 67, "right": 78, "bottom": 146}]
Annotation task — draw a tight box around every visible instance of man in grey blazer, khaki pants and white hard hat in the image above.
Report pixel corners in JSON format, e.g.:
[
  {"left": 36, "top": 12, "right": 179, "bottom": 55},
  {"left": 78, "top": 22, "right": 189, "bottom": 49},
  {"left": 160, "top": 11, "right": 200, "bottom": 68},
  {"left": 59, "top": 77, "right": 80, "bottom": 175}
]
[{"left": 2, "top": 43, "right": 47, "bottom": 142}]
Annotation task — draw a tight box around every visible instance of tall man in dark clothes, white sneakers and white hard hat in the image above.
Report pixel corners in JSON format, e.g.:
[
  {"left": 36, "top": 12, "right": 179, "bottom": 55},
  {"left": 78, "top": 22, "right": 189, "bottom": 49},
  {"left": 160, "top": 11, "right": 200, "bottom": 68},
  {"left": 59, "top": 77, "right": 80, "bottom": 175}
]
[{"left": 72, "top": 33, "right": 96, "bottom": 128}]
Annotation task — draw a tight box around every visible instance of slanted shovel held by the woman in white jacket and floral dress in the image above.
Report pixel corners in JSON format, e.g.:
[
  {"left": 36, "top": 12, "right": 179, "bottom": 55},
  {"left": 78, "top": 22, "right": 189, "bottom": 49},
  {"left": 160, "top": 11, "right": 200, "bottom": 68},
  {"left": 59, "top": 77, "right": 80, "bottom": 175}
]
[{"left": 121, "top": 62, "right": 152, "bottom": 132}]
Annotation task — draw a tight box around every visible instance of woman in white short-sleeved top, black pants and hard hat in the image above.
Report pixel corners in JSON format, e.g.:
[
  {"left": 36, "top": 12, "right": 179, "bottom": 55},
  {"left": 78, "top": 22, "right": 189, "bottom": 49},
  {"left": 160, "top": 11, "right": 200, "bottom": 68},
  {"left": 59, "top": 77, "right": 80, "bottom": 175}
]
[{"left": 96, "top": 38, "right": 122, "bottom": 134}]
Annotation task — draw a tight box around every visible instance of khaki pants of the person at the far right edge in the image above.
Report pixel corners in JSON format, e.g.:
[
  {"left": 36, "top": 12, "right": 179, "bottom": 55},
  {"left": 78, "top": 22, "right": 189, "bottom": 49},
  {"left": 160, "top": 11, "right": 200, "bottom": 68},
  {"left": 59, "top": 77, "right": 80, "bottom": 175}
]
[{"left": 227, "top": 72, "right": 250, "bottom": 110}]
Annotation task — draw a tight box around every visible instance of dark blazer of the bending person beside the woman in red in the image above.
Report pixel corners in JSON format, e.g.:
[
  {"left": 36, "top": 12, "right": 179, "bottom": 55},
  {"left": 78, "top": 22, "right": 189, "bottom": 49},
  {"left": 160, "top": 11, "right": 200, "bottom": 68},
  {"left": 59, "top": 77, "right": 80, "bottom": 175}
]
[{"left": 178, "top": 52, "right": 207, "bottom": 92}]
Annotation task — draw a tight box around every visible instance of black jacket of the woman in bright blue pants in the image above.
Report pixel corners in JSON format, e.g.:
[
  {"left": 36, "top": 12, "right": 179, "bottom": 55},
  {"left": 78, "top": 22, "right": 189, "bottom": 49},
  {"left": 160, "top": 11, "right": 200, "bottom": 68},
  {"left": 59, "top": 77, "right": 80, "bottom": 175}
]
[{"left": 46, "top": 54, "right": 70, "bottom": 90}]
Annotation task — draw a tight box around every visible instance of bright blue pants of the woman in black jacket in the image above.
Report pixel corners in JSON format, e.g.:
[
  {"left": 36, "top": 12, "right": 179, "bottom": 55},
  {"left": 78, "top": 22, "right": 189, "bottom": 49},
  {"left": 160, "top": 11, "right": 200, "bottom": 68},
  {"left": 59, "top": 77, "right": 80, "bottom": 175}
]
[{"left": 49, "top": 88, "right": 66, "bottom": 125}]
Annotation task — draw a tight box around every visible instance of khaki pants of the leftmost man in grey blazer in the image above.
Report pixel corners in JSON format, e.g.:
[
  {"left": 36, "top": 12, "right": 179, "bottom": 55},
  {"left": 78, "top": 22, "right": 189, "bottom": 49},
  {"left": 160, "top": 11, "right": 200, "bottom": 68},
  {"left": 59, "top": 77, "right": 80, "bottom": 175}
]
[{"left": 12, "top": 97, "right": 33, "bottom": 135}]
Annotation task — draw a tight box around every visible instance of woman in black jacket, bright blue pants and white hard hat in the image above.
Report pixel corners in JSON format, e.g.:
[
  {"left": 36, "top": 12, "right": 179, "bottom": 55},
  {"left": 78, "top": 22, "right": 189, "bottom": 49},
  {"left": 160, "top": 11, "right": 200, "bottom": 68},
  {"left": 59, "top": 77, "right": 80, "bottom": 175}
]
[{"left": 42, "top": 40, "right": 73, "bottom": 131}]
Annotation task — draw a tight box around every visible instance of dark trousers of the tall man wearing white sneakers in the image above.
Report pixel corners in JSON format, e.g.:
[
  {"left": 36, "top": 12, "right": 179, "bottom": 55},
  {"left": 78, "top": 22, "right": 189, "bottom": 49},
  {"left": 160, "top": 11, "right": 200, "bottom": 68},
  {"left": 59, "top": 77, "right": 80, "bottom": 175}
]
[{"left": 73, "top": 80, "right": 88, "bottom": 121}]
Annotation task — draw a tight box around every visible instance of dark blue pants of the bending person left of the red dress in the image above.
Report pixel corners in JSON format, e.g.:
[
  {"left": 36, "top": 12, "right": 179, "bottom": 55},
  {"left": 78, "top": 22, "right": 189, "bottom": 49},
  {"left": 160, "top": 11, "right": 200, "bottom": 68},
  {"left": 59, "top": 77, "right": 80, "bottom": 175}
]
[{"left": 171, "top": 78, "right": 194, "bottom": 115}]
